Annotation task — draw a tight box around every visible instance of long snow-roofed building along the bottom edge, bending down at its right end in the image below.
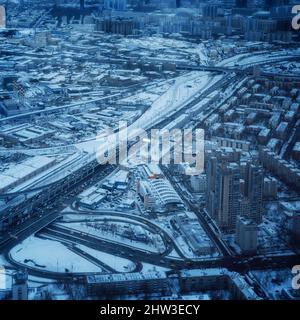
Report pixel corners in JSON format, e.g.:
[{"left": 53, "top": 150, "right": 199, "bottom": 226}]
[{"left": 86, "top": 268, "right": 259, "bottom": 300}]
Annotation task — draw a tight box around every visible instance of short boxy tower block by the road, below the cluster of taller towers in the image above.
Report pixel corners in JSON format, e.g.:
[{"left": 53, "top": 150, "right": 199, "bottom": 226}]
[{"left": 235, "top": 217, "right": 258, "bottom": 254}]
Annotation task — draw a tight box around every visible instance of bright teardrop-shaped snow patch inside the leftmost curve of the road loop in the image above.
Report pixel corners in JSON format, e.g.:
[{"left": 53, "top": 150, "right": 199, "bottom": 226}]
[{"left": 10, "top": 236, "right": 102, "bottom": 273}]
